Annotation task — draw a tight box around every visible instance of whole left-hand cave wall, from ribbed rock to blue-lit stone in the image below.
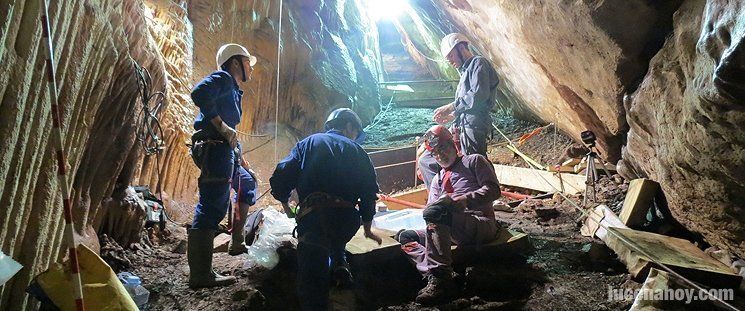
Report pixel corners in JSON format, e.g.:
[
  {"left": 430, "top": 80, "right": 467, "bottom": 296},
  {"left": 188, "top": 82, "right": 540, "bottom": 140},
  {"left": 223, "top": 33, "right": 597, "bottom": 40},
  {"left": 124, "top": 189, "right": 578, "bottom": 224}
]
[{"left": 0, "top": 0, "right": 379, "bottom": 310}]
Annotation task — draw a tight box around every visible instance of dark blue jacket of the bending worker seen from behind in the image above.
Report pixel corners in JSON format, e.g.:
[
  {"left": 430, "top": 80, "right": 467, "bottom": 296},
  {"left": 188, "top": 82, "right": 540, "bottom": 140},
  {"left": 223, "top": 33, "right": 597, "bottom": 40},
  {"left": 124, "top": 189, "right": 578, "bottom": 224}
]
[{"left": 269, "top": 130, "right": 379, "bottom": 221}]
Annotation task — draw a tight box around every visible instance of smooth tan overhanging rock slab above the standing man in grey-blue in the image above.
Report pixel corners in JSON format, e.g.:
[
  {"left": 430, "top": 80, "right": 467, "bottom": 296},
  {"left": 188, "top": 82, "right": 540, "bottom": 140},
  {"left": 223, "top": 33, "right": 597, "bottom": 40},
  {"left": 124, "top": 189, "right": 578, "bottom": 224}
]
[{"left": 416, "top": 0, "right": 680, "bottom": 163}]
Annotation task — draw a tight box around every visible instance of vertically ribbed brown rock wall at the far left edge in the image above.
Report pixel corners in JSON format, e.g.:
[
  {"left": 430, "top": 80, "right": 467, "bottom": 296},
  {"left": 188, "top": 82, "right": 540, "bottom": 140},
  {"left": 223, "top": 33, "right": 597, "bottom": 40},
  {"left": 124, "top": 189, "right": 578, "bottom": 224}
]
[{"left": 0, "top": 0, "right": 163, "bottom": 310}]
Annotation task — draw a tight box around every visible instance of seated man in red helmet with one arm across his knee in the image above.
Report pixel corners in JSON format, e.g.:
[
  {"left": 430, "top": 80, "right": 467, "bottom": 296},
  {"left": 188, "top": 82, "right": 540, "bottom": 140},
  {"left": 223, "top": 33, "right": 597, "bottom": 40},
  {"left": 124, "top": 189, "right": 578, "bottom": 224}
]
[{"left": 396, "top": 125, "right": 500, "bottom": 305}]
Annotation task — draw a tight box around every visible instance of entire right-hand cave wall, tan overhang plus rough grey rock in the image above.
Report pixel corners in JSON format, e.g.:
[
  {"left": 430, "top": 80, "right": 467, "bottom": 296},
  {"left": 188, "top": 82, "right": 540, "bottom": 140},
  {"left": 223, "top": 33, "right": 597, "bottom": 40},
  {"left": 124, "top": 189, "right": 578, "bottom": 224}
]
[{"left": 414, "top": 0, "right": 745, "bottom": 257}]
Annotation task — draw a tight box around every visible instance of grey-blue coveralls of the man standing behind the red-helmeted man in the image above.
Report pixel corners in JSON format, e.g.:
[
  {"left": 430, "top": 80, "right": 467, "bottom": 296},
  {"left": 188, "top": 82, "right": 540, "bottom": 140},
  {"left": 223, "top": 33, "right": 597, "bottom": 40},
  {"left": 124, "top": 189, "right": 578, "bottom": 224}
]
[{"left": 418, "top": 56, "right": 499, "bottom": 188}]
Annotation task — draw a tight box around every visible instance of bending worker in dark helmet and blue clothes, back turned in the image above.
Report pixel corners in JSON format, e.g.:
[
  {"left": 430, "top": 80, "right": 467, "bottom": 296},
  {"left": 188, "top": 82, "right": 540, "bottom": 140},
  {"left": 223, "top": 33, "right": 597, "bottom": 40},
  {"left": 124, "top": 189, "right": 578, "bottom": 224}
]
[{"left": 269, "top": 108, "right": 382, "bottom": 310}]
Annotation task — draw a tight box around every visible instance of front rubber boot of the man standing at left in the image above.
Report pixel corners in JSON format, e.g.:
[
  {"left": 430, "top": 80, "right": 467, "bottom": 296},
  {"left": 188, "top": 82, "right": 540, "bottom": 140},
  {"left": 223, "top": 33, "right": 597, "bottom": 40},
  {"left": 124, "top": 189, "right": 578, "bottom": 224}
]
[{"left": 186, "top": 229, "right": 236, "bottom": 289}]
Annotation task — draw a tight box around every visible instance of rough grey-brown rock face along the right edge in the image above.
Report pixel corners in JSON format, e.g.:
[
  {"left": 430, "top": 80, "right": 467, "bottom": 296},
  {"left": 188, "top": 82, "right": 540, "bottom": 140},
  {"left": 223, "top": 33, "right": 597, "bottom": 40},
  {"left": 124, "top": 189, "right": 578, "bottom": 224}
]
[{"left": 620, "top": 0, "right": 745, "bottom": 258}]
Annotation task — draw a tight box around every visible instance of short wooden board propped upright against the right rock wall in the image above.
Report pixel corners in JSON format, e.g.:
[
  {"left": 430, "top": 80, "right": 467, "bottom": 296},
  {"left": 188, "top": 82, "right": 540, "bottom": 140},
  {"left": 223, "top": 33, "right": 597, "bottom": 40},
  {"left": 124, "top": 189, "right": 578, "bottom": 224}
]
[{"left": 619, "top": 178, "right": 660, "bottom": 228}]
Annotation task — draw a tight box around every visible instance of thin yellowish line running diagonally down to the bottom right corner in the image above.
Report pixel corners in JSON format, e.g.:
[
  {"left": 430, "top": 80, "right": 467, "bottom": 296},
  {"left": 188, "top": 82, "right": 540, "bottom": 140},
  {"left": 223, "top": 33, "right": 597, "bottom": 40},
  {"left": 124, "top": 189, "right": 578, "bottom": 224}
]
[{"left": 492, "top": 123, "right": 739, "bottom": 311}]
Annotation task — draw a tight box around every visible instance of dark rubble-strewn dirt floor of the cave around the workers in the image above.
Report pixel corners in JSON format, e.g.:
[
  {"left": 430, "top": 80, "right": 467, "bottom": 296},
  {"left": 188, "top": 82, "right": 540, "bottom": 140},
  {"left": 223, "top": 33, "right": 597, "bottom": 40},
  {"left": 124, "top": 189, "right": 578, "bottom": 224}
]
[{"left": 102, "top": 109, "right": 740, "bottom": 310}]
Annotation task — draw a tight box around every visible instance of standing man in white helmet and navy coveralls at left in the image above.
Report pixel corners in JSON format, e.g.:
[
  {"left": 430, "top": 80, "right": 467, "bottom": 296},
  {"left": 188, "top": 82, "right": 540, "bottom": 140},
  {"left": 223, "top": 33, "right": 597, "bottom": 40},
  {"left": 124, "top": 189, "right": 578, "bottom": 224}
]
[{"left": 187, "top": 44, "right": 256, "bottom": 288}]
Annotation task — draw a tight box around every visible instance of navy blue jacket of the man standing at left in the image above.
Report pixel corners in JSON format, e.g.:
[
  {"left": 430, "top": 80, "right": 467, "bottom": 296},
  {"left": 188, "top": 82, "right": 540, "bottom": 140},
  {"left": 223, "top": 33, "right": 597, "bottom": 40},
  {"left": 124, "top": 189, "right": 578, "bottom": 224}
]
[{"left": 191, "top": 70, "right": 243, "bottom": 130}]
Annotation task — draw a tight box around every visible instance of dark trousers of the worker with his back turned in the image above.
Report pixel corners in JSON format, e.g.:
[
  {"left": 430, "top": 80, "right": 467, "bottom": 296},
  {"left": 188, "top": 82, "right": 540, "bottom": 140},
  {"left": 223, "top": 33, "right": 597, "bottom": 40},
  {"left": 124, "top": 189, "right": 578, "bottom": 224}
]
[{"left": 297, "top": 207, "right": 360, "bottom": 310}]
